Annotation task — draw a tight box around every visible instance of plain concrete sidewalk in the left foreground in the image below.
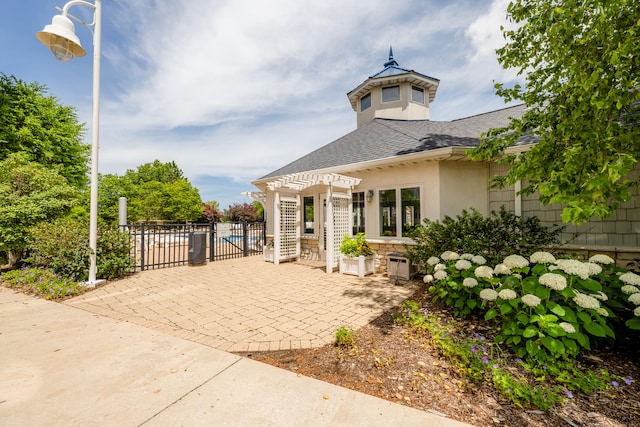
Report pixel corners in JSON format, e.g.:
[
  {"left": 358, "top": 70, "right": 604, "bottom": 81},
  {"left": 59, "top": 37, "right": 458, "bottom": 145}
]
[{"left": 0, "top": 287, "right": 472, "bottom": 427}]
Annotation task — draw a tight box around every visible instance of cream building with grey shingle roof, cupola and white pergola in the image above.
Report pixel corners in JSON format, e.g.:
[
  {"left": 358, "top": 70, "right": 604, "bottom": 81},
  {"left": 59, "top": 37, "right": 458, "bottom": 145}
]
[{"left": 248, "top": 50, "right": 640, "bottom": 272}]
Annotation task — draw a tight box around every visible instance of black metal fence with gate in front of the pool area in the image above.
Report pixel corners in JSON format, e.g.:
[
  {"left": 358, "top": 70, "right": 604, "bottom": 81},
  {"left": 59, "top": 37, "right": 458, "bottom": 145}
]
[{"left": 122, "top": 222, "right": 265, "bottom": 271}]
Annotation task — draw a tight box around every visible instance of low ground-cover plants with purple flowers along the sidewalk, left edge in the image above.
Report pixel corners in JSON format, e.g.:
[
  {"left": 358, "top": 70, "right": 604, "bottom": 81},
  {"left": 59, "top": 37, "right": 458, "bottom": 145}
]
[{"left": 0, "top": 268, "right": 86, "bottom": 299}]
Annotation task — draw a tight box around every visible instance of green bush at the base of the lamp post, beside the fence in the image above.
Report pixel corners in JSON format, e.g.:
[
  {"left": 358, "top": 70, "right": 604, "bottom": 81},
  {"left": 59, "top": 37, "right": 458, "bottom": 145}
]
[{"left": 25, "top": 218, "right": 134, "bottom": 281}]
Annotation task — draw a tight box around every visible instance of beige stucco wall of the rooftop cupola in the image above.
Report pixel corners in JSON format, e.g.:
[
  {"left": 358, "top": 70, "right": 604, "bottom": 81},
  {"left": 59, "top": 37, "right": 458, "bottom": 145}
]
[{"left": 357, "top": 82, "right": 429, "bottom": 127}]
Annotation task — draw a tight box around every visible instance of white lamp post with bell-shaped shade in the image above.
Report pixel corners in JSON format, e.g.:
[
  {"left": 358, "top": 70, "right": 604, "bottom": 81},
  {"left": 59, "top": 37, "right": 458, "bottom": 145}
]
[{"left": 36, "top": 0, "right": 102, "bottom": 287}]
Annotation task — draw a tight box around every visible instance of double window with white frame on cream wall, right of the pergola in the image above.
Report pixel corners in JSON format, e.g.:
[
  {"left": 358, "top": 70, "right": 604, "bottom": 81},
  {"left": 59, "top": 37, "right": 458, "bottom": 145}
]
[{"left": 378, "top": 187, "right": 420, "bottom": 237}]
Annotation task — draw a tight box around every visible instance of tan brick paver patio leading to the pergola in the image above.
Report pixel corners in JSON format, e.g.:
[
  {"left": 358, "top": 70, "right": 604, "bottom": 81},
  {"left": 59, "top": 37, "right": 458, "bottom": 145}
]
[{"left": 64, "top": 256, "right": 418, "bottom": 352}]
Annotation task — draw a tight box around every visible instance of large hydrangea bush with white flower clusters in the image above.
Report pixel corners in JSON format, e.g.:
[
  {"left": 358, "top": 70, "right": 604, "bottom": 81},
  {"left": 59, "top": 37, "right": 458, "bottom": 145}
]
[{"left": 424, "top": 251, "right": 640, "bottom": 360}]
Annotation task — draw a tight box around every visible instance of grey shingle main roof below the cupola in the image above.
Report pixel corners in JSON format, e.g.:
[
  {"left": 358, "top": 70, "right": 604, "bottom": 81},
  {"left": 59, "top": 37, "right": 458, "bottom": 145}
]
[{"left": 260, "top": 105, "right": 532, "bottom": 179}]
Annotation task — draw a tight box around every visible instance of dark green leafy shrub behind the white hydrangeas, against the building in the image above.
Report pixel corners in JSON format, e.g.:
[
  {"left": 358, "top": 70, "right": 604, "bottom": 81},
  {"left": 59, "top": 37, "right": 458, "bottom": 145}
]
[{"left": 407, "top": 206, "right": 564, "bottom": 264}]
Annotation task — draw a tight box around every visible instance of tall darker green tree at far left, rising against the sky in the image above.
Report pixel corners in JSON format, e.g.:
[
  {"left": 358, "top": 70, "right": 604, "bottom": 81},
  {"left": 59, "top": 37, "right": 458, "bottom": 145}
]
[{"left": 0, "top": 74, "right": 90, "bottom": 188}]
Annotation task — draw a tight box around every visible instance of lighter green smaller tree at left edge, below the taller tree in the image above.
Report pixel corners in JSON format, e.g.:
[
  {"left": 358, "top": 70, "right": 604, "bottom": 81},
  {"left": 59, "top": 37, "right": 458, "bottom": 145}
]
[{"left": 0, "top": 153, "right": 78, "bottom": 266}]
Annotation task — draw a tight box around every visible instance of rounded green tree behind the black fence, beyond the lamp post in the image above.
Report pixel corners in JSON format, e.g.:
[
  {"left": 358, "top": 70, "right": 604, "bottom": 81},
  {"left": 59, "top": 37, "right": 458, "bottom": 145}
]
[{"left": 98, "top": 160, "right": 203, "bottom": 223}]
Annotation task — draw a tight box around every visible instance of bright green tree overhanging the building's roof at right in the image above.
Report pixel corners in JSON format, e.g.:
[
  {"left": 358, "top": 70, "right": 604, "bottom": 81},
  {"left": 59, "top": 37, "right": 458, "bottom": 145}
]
[{"left": 470, "top": 0, "right": 640, "bottom": 224}]
